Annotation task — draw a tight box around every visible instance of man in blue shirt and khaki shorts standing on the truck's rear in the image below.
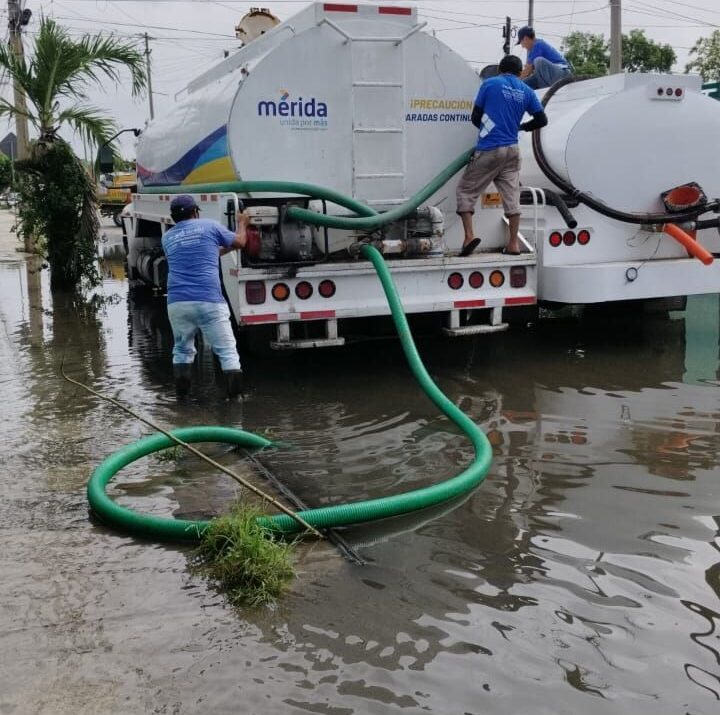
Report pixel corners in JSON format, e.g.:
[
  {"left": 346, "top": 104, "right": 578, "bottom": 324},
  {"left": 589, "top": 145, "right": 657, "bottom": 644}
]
[{"left": 456, "top": 55, "right": 547, "bottom": 256}]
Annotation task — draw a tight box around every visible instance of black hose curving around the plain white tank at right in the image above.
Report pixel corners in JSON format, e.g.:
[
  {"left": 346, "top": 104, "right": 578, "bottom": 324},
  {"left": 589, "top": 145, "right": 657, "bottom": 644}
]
[{"left": 532, "top": 75, "right": 720, "bottom": 228}]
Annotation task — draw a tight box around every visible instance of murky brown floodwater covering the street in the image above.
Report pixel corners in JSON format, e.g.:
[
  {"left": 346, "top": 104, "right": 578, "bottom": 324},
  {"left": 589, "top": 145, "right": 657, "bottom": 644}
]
[{"left": 0, "top": 231, "right": 720, "bottom": 715}]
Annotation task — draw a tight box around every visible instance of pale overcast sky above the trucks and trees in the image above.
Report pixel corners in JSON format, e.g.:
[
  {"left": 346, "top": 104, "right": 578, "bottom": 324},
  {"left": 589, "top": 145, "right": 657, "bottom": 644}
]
[{"left": 0, "top": 0, "right": 720, "bottom": 157}]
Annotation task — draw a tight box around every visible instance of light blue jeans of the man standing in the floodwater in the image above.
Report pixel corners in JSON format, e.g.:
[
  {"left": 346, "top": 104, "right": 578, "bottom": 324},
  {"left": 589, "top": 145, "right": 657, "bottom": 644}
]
[{"left": 168, "top": 300, "right": 240, "bottom": 371}]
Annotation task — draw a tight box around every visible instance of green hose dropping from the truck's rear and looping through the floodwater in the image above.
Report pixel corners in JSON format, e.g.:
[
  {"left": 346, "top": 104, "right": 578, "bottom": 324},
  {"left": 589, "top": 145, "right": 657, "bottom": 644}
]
[{"left": 87, "top": 243, "right": 492, "bottom": 541}]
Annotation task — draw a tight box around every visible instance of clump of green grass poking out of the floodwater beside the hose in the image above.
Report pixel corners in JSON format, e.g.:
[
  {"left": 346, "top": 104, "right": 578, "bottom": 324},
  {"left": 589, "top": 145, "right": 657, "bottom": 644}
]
[{"left": 192, "top": 502, "right": 295, "bottom": 607}]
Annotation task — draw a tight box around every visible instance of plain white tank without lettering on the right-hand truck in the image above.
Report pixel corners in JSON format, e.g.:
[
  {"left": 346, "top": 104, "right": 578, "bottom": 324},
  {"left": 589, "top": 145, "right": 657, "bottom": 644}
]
[{"left": 522, "top": 73, "right": 720, "bottom": 213}]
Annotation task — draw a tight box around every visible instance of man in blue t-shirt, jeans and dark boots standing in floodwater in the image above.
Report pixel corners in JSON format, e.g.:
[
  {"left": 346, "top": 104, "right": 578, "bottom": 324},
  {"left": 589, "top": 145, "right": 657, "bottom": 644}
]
[{"left": 162, "top": 194, "right": 250, "bottom": 398}]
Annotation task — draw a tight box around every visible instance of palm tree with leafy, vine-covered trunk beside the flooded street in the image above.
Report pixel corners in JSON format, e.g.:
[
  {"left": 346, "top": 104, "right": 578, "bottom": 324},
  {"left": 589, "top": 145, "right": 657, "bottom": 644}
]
[{"left": 0, "top": 17, "right": 147, "bottom": 288}]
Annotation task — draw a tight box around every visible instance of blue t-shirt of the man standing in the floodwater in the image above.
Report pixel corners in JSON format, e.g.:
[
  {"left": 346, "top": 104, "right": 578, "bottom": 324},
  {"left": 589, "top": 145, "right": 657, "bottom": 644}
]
[{"left": 162, "top": 218, "right": 235, "bottom": 303}]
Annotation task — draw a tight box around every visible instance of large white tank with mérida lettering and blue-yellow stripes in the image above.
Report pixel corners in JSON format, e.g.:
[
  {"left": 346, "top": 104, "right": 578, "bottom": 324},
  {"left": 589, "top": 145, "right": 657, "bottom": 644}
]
[{"left": 137, "top": 3, "right": 480, "bottom": 215}]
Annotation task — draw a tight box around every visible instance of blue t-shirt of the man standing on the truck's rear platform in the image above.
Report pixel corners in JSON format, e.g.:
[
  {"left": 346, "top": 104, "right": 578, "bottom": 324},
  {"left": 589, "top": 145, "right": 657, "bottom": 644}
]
[{"left": 475, "top": 74, "right": 544, "bottom": 150}]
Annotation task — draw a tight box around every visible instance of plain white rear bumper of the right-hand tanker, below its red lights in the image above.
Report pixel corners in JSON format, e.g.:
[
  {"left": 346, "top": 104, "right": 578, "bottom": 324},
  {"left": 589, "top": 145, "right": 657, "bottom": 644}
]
[{"left": 538, "top": 258, "right": 720, "bottom": 304}]
